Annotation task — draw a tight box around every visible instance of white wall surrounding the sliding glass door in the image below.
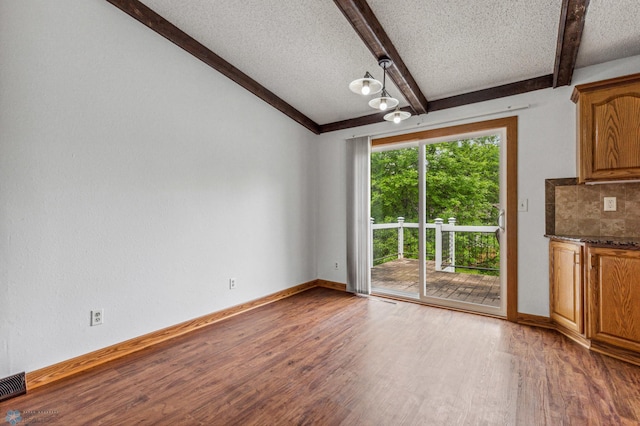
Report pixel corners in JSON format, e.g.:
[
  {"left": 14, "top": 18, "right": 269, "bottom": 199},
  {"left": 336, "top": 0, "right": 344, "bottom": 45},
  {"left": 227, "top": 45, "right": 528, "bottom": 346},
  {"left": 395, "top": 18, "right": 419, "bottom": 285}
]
[{"left": 317, "top": 56, "right": 640, "bottom": 316}]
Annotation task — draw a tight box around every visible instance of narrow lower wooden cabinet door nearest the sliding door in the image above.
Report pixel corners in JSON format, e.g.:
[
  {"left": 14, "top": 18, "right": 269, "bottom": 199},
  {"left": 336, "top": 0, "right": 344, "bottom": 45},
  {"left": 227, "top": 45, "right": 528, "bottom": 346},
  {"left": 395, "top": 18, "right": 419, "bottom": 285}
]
[{"left": 549, "top": 241, "right": 584, "bottom": 334}]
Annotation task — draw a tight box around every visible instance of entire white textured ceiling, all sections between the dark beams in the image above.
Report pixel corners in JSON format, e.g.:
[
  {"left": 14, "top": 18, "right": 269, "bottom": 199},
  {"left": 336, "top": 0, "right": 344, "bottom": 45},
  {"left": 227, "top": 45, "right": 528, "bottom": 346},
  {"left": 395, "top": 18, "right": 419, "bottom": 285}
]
[{"left": 142, "top": 0, "right": 640, "bottom": 124}]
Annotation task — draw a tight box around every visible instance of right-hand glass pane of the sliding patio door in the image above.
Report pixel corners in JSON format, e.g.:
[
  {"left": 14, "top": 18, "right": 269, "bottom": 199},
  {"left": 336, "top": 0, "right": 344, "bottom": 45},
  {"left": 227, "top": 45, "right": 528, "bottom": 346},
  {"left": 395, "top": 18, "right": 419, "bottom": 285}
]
[{"left": 425, "top": 135, "right": 500, "bottom": 307}]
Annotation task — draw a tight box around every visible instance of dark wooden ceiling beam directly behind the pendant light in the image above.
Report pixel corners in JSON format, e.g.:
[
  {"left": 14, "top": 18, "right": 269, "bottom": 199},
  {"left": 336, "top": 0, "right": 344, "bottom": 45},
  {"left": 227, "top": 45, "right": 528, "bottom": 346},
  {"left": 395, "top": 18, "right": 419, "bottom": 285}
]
[{"left": 334, "top": 0, "right": 427, "bottom": 115}]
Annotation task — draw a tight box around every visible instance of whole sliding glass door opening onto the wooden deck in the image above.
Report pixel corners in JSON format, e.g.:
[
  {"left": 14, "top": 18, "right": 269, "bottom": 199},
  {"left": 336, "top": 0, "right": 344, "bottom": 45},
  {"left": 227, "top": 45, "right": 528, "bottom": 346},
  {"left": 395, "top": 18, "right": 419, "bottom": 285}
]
[{"left": 370, "top": 128, "right": 506, "bottom": 316}]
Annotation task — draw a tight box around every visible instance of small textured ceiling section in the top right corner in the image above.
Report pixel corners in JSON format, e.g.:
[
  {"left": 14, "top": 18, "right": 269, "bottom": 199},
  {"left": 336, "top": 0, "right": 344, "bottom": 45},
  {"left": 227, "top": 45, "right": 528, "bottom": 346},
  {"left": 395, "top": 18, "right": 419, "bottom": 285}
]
[{"left": 576, "top": 0, "right": 640, "bottom": 67}]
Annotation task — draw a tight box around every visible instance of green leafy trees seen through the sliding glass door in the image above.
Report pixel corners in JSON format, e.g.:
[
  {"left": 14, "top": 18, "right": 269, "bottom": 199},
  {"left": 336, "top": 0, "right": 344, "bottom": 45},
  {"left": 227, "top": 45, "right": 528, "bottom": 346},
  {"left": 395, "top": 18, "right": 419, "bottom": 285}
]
[{"left": 371, "top": 136, "right": 500, "bottom": 267}]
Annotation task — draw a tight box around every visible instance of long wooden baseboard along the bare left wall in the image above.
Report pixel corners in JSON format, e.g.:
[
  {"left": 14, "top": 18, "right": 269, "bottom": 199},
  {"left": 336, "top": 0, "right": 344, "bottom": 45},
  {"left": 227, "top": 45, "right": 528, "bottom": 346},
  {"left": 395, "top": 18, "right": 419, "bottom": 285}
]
[{"left": 27, "top": 280, "right": 319, "bottom": 390}]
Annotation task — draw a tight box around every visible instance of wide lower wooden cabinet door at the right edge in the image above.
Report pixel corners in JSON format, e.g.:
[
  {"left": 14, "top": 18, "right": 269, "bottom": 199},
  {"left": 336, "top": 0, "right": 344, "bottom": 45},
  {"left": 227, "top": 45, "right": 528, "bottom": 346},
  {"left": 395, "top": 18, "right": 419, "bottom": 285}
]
[{"left": 587, "top": 248, "right": 640, "bottom": 351}]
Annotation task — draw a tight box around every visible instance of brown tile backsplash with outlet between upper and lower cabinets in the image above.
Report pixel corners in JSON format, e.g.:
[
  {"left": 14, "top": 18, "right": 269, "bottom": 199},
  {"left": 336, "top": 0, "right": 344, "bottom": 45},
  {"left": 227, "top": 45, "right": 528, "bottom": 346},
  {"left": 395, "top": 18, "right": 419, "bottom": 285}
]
[{"left": 547, "top": 179, "right": 640, "bottom": 238}]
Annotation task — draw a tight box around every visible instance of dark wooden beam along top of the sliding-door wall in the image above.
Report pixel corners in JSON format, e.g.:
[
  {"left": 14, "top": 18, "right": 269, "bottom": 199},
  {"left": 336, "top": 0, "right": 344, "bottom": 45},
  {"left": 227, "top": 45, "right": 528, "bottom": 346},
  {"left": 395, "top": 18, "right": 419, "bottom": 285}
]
[{"left": 320, "top": 74, "right": 553, "bottom": 133}]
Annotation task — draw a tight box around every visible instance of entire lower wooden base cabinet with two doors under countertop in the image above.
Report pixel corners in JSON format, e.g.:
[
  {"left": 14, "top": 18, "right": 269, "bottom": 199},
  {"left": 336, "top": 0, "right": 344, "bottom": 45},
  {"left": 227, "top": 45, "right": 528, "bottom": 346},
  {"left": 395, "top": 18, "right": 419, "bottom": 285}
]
[{"left": 549, "top": 239, "right": 640, "bottom": 365}]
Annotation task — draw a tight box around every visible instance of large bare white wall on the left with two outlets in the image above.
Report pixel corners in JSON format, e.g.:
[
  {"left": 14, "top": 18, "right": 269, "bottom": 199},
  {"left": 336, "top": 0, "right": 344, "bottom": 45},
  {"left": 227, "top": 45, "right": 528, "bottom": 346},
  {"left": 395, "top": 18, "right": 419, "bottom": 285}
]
[{"left": 0, "top": 0, "right": 317, "bottom": 377}]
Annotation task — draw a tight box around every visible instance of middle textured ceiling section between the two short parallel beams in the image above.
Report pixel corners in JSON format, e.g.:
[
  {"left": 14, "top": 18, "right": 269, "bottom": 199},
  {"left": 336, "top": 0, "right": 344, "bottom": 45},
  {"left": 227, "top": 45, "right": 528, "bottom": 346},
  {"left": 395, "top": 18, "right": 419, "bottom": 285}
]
[{"left": 367, "top": 0, "right": 564, "bottom": 100}]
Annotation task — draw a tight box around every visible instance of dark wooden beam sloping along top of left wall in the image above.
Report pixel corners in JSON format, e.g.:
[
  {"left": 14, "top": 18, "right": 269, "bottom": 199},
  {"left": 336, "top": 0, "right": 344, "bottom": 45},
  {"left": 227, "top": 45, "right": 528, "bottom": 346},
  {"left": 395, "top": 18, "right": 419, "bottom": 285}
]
[{"left": 107, "top": 0, "right": 320, "bottom": 134}]
